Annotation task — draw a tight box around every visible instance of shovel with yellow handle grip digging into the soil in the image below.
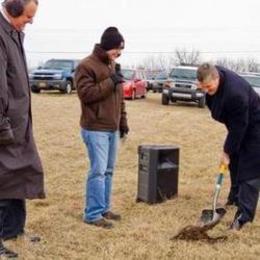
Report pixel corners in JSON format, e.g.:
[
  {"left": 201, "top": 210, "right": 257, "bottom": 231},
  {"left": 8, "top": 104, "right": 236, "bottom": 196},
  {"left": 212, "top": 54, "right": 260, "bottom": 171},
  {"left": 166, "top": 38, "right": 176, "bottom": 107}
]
[{"left": 200, "top": 164, "right": 228, "bottom": 226}]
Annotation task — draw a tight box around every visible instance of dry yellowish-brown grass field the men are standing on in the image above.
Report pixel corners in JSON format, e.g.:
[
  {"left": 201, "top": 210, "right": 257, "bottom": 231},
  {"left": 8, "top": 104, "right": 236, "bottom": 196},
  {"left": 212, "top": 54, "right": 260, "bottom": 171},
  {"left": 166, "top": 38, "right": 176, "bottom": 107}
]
[{"left": 4, "top": 93, "right": 260, "bottom": 260}]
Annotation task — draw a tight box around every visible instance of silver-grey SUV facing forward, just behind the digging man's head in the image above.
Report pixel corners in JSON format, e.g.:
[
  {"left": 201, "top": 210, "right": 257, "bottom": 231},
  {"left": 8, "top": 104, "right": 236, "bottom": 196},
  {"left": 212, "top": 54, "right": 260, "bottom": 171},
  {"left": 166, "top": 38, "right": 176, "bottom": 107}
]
[{"left": 162, "top": 66, "right": 206, "bottom": 108}]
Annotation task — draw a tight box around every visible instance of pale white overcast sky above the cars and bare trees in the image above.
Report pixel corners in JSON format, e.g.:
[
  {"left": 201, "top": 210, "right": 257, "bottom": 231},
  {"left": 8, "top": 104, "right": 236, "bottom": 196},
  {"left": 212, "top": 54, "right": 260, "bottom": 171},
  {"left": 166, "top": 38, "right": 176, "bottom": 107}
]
[{"left": 14, "top": 0, "right": 260, "bottom": 65}]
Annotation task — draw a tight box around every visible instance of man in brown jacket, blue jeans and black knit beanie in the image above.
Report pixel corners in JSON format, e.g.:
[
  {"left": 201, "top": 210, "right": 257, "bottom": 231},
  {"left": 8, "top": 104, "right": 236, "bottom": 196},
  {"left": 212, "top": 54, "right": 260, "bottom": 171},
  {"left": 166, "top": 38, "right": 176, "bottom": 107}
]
[{"left": 75, "top": 27, "right": 129, "bottom": 228}]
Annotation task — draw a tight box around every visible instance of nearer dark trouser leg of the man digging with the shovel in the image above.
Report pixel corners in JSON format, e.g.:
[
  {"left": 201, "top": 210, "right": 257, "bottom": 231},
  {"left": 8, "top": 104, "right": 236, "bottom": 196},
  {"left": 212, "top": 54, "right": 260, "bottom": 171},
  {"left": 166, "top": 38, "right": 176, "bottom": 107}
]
[{"left": 235, "top": 178, "right": 260, "bottom": 224}]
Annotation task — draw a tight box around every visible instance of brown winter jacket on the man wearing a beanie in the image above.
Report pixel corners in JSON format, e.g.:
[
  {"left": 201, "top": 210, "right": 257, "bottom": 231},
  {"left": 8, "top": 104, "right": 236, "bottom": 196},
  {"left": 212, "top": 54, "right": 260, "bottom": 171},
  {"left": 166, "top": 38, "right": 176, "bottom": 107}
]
[{"left": 75, "top": 44, "right": 127, "bottom": 131}]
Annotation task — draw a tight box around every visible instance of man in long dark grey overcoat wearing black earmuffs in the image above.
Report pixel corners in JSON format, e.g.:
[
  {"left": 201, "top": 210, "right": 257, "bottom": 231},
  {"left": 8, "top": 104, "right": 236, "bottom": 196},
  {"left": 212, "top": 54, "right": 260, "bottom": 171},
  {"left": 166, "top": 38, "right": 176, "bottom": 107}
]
[{"left": 0, "top": 0, "right": 45, "bottom": 254}]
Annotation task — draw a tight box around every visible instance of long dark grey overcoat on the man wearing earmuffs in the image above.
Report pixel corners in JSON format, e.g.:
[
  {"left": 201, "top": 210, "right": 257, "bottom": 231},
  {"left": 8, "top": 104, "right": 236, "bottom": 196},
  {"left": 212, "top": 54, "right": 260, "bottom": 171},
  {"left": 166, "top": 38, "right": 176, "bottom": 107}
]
[{"left": 0, "top": 13, "right": 45, "bottom": 199}]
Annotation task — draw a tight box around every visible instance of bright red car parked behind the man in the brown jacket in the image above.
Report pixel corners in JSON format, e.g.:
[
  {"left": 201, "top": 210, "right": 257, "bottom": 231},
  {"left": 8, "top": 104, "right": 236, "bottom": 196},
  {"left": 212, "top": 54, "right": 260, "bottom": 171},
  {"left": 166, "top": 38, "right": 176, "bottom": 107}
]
[{"left": 121, "top": 69, "right": 147, "bottom": 100}]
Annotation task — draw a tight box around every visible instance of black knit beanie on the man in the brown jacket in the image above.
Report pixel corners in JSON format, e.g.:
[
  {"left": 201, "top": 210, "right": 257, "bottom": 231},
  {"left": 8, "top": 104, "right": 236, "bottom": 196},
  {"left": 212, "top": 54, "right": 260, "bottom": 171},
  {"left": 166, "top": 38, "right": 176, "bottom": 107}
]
[{"left": 100, "top": 27, "right": 125, "bottom": 51}]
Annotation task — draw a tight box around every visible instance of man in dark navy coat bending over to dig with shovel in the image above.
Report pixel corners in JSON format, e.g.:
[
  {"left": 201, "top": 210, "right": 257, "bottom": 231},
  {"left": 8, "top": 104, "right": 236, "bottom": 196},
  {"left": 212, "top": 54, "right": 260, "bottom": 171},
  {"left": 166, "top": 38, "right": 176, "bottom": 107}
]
[{"left": 197, "top": 63, "right": 260, "bottom": 230}]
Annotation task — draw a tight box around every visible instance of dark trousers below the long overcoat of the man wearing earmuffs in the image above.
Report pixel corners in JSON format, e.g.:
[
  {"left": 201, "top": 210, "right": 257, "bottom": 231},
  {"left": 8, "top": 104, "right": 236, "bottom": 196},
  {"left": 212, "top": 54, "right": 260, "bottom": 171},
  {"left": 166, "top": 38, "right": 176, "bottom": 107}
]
[{"left": 0, "top": 199, "right": 26, "bottom": 240}]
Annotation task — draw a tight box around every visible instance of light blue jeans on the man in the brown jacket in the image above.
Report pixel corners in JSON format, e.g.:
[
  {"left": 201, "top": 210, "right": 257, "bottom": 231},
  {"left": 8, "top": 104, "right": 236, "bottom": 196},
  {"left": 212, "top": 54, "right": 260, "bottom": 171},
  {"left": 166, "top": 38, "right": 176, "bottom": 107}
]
[{"left": 81, "top": 129, "right": 119, "bottom": 222}]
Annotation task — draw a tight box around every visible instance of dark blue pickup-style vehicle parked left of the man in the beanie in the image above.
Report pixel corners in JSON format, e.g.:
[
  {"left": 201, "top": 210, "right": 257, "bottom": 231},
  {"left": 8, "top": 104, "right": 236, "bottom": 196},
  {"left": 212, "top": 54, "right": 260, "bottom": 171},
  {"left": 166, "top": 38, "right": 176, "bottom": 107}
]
[{"left": 29, "top": 59, "right": 79, "bottom": 94}]
